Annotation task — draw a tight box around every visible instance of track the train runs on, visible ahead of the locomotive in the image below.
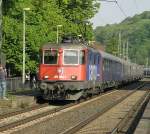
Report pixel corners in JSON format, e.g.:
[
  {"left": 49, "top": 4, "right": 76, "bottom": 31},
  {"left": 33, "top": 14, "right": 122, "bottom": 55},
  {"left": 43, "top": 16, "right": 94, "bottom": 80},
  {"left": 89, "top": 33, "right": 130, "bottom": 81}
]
[{"left": 0, "top": 101, "right": 73, "bottom": 132}]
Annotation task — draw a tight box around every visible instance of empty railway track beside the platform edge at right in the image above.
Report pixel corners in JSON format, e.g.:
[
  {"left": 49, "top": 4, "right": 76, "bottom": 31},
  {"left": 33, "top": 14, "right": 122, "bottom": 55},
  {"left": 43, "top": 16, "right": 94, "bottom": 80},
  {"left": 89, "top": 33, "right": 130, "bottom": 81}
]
[{"left": 65, "top": 83, "right": 150, "bottom": 134}]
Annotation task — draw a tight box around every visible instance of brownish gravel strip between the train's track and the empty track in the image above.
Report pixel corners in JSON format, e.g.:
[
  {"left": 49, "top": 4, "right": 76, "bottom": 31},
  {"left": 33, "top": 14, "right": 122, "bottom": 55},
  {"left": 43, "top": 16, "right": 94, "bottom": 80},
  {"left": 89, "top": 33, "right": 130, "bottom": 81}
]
[{"left": 7, "top": 90, "right": 132, "bottom": 134}]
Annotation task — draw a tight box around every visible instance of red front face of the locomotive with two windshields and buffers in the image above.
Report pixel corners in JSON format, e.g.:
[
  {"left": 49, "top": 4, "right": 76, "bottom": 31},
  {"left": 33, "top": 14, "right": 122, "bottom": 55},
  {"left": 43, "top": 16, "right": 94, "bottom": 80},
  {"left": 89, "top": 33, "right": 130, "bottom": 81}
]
[{"left": 39, "top": 44, "right": 86, "bottom": 100}]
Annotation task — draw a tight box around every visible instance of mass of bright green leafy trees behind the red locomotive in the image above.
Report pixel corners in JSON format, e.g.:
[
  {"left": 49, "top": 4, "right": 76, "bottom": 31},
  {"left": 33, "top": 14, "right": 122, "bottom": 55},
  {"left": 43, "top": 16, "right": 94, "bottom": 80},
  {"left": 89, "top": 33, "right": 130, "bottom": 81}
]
[{"left": 2, "top": 0, "right": 99, "bottom": 75}]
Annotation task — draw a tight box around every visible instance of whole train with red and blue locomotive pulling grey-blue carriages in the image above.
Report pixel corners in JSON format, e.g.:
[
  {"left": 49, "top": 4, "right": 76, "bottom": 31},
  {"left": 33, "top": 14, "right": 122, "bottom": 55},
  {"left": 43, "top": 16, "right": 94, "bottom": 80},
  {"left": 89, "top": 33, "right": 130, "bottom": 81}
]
[{"left": 38, "top": 39, "right": 143, "bottom": 100}]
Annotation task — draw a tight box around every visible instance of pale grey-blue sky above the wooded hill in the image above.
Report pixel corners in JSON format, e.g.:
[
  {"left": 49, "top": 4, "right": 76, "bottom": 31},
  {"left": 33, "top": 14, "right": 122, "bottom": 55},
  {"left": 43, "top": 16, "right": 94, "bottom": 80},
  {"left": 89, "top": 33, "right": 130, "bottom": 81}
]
[{"left": 91, "top": 0, "right": 150, "bottom": 28}]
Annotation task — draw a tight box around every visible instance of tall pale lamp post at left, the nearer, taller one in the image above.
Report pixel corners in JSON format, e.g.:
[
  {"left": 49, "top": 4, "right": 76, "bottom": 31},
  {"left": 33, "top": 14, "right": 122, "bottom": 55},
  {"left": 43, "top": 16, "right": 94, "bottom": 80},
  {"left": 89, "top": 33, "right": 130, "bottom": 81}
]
[{"left": 22, "top": 8, "right": 30, "bottom": 84}]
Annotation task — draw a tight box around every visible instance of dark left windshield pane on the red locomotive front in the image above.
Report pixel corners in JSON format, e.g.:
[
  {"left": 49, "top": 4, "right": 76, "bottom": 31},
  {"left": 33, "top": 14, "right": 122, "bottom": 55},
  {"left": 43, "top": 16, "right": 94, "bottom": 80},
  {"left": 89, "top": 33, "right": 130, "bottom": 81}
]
[{"left": 44, "top": 50, "right": 58, "bottom": 64}]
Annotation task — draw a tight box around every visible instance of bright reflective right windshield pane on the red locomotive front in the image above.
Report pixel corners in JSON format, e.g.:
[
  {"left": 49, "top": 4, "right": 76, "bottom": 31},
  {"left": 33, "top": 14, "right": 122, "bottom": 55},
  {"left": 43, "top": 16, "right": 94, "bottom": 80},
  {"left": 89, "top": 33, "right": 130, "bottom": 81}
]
[{"left": 64, "top": 50, "right": 78, "bottom": 65}]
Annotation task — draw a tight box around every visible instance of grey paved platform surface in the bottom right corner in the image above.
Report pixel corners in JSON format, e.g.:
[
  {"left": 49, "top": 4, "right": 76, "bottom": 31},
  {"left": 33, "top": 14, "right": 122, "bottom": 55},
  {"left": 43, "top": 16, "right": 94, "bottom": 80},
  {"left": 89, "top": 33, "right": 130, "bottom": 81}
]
[{"left": 134, "top": 101, "right": 150, "bottom": 134}]
